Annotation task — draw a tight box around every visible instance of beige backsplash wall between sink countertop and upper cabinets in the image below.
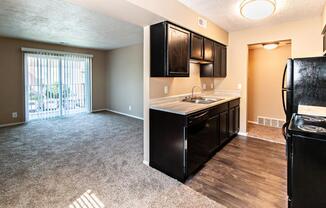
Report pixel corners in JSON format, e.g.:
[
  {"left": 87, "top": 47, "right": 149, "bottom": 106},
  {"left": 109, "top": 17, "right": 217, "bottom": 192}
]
[{"left": 150, "top": 63, "right": 214, "bottom": 99}]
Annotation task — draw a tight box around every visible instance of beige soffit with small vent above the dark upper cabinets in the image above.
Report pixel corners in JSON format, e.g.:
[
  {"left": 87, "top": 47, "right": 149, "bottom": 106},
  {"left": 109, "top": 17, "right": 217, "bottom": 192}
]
[{"left": 128, "top": 0, "right": 228, "bottom": 45}]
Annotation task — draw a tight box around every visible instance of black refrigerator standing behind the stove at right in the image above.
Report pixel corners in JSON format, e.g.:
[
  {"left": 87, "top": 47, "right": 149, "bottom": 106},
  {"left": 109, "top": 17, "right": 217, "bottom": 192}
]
[{"left": 282, "top": 57, "right": 326, "bottom": 124}]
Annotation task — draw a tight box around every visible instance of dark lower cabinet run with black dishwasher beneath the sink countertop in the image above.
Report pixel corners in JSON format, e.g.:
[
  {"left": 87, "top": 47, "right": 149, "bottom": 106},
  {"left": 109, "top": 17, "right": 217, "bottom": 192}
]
[{"left": 150, "top": 99, "right": 240, "bottom": 182}]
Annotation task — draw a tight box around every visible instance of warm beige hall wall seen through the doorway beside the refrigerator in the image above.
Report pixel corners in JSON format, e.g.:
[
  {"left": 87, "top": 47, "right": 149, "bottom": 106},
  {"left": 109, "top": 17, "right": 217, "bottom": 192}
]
[{"left": 248, "top": 45, "right": 291, "bottom": 122}]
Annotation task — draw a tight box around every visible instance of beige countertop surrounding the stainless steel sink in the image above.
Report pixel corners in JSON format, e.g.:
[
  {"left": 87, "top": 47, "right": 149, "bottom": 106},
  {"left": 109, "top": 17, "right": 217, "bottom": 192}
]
[{"left": 150, "top": 95, "right": 240, "bottom": 115}]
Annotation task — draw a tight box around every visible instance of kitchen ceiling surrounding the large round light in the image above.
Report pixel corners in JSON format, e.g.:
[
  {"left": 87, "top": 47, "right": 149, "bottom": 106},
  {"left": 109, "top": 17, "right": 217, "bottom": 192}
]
[{"left": 179, "top": 0, "right": 326, "bottom": 31}]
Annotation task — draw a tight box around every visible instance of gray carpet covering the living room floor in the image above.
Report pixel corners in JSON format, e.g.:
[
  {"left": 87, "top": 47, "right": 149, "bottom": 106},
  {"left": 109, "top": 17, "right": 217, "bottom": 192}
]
[{"left": 0, "top": 113, "right": 223, "bottom": 208}]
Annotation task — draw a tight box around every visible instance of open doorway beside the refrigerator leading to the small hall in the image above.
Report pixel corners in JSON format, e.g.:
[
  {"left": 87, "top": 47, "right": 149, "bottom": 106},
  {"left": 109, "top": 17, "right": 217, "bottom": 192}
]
[{"left": 247, "top": 40, "right": 291, "bottom": 144}]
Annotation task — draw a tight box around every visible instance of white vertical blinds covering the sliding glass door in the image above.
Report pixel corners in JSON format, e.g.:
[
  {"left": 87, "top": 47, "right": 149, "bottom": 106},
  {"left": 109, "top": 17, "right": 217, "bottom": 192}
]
[{"left": 23, "top": 49, "right": 92, "bottom": 120}]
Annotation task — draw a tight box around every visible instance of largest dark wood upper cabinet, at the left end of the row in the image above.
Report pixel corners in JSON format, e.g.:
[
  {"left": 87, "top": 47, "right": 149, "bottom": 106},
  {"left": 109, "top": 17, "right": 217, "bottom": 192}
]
[{"left": 150, "top": 22, "right": 190, "bottom": 77}]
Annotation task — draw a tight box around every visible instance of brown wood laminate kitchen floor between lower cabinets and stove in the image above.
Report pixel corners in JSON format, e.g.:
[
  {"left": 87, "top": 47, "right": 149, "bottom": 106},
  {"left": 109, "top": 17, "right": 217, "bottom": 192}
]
[{"left": 186, "top": 136, "right": 287, "bottom": 208}]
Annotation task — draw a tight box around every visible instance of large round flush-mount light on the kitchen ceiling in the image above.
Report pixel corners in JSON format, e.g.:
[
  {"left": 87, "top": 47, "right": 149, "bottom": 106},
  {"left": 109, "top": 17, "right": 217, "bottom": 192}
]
[{"left": 240, "top": 0, "right": 276, "bottom": 20}]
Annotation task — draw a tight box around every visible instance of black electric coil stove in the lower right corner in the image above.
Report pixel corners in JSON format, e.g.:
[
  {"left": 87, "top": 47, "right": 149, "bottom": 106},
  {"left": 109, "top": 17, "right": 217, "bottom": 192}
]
[{"left": 286, "top": 114, "right": 326, "bottom": 208}]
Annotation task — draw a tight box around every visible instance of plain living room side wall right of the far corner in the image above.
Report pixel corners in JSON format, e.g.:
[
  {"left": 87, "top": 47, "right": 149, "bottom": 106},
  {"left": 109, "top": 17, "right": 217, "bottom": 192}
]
[{"left": 106, "top": 44, "right": 143, "bottom": 118}]
